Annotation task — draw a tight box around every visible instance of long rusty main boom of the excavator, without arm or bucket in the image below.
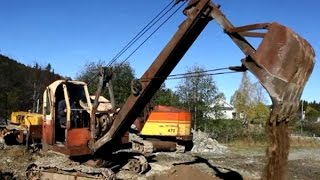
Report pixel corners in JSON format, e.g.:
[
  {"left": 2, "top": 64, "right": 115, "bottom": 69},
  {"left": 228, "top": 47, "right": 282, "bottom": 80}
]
[{"left": 93, "top": 0, "right": 212, "bottom": 150}]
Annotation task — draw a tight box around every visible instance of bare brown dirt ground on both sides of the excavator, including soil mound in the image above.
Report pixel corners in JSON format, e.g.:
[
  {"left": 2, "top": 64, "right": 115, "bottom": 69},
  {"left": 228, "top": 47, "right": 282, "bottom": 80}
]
[{"left": 0, "top": 143, "right": 320, "bottom": 180}]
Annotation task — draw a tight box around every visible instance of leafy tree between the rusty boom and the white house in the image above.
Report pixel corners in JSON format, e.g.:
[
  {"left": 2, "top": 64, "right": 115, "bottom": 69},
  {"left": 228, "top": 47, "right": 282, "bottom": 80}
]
[{"left": 177, "top": 66, "right": 224, "bottom": 129}]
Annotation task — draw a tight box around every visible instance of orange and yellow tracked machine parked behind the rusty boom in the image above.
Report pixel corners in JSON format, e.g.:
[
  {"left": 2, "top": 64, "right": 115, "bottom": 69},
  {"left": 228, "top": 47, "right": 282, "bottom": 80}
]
[{"left": 131, "top": 105, "right": 193, "bottom": 153}]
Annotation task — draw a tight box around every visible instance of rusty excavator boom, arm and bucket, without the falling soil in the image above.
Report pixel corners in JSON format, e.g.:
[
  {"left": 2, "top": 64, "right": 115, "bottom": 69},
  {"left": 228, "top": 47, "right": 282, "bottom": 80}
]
[{"left": 91, "top": 0, "right": 314, "bottom": 151}]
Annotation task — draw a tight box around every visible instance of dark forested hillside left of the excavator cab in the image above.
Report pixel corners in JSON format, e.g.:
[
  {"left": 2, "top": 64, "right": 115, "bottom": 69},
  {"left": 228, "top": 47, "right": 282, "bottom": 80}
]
[{"left": 0, "top": 55, "right": 62, "bottom": 119}]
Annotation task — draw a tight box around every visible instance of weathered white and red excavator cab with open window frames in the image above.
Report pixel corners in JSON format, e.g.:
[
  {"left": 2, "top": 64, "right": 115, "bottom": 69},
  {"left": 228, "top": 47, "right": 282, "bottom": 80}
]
[{"left": 43, "top": 80, "right": 92, "bottom": 156}]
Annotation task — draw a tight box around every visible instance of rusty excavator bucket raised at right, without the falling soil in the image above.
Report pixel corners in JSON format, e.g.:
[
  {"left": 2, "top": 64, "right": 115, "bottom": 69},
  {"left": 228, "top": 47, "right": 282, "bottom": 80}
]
[{"left": 243, "top": 23, "right": 315, "bottom": 118}]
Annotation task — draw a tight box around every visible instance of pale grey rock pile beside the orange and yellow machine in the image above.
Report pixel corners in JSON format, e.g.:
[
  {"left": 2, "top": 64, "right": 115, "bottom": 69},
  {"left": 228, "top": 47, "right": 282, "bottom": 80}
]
[{"left": 191, "top": 130, "right": 228, "bottom": 154}]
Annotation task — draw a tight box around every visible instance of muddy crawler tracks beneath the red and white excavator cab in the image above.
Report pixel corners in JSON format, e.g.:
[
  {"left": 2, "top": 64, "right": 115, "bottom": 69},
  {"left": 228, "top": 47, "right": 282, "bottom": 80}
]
[{"left": 26, "top": 153, "right": 149, "bottom": 180}]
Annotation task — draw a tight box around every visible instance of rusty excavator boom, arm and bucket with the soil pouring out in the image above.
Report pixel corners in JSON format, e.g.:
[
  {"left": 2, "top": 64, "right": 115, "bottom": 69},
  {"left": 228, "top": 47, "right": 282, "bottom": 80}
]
[{"left": 90, "top": 0, "right": 315, "bottom": 179}]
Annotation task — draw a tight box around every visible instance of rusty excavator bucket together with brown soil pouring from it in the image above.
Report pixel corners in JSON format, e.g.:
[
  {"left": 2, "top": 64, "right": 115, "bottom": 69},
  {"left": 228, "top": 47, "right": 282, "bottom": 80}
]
[{"left": 242, "top": 23, "right": 315, "bottom": 179}]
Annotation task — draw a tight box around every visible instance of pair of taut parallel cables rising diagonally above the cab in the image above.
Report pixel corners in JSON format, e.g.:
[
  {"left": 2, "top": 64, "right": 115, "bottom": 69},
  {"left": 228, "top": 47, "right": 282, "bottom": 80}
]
[{"left": 108, "top": 0, "right": 174, "bottom": 66}]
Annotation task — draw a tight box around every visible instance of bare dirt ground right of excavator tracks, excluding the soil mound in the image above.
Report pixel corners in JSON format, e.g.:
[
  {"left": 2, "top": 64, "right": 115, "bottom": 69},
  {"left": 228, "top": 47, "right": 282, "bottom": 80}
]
[{"left": 118, "top": 147, "right": 320, "bottom": 180}]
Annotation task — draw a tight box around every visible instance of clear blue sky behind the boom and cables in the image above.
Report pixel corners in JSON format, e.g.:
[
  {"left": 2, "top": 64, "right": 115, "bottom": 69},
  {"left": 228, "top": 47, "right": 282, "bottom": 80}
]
[{"left": 0, "top": 0, "right": 320, "bottom": 101}]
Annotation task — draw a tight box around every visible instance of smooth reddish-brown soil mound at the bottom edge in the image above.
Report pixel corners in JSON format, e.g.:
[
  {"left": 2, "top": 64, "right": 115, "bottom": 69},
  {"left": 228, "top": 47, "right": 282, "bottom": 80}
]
[{"left": 154, "top": 165, "right": 219, "bottom": 180}]
